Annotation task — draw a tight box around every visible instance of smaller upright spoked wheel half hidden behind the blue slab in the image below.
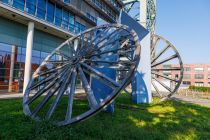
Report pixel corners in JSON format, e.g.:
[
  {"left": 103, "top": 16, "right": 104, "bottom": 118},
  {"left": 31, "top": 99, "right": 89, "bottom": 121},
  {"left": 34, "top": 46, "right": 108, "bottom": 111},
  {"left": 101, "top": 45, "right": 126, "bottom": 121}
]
[{"left": 151, "top": 35, "right": 183, "bottom": 99}]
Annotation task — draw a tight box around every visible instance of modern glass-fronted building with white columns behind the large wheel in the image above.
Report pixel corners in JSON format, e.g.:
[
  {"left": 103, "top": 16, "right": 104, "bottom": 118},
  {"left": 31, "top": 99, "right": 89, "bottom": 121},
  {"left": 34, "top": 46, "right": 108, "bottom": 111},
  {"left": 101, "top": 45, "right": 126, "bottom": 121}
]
[{"left": 0, "top": 0, "right": 123, "bottom": 92}]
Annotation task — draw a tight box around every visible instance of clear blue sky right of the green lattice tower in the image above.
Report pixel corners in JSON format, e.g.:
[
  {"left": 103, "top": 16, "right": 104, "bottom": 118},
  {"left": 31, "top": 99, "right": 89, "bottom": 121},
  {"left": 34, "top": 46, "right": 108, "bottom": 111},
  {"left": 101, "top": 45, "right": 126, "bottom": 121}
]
[{"left": 156, "top": 0, "right": 210, "bottom": 64}]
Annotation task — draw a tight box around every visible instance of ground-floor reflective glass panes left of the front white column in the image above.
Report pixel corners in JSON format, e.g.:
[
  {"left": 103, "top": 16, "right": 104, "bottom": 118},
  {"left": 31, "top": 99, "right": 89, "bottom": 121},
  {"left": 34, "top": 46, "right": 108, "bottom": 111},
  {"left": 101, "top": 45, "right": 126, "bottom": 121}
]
[{"left": 0, "top": 43, "right": 26, "bottom": 92}]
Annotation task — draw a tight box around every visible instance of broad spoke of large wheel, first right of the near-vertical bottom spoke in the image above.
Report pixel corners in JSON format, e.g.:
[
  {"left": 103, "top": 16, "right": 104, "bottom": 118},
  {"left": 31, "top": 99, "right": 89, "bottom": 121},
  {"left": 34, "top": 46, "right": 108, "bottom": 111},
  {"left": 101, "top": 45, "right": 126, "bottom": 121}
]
[{"left": 79, "top": 66, "right": 98, "bottom": 108}]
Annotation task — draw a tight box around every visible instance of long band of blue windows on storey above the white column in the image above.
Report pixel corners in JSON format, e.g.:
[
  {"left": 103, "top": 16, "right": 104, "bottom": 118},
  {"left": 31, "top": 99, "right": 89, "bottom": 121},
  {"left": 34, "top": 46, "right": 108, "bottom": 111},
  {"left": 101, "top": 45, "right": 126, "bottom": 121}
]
[{"left": 0, "top": 0, "right": 86, "bottom": 34}]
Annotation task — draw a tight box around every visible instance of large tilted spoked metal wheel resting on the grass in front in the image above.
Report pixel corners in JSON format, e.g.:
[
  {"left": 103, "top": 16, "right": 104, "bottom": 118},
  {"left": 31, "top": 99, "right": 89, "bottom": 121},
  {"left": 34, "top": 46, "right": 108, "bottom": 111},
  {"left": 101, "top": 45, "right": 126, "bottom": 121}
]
[{"left": 23, "top": 24, "right": 140, "bottom": 126}]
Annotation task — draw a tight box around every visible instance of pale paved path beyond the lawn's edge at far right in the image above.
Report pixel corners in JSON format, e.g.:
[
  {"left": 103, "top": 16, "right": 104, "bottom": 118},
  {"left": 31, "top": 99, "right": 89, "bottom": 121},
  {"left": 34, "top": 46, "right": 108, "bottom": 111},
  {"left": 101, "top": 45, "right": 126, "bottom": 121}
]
[{"left": 172, "top": 95, "right": 210, "bottom": 107}]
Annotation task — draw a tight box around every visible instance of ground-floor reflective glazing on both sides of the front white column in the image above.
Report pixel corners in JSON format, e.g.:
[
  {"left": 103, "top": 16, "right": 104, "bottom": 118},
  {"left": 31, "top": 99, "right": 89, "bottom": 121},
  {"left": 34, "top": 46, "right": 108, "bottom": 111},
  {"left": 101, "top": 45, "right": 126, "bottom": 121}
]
[{"left": 0, "top": 43, "right": 58, "bottom": 92}]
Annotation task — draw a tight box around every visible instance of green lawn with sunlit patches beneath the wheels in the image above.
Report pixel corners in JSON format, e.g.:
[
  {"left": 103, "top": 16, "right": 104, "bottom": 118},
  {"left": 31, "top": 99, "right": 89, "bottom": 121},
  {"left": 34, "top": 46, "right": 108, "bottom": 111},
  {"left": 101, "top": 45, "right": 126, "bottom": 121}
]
[{"left": 0, "top": 95, "right": 210, "bottom": 140}]
